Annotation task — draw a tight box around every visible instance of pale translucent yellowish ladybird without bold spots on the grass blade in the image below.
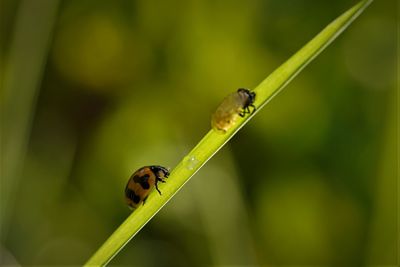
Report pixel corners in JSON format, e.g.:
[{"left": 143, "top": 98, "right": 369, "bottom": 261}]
[{"left": 211, "top": 88, "right": 256, "bottom": 133}]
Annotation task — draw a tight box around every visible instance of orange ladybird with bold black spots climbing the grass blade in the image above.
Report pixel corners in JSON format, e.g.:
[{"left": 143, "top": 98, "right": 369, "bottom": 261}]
[{"left": 125, "top": 166, "right": 169, "bottom": 209}]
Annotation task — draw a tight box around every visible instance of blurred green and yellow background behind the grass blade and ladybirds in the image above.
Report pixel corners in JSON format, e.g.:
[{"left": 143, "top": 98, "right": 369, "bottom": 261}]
[{"left": 0, "top": 0, "right": 398, "bottom": 266}]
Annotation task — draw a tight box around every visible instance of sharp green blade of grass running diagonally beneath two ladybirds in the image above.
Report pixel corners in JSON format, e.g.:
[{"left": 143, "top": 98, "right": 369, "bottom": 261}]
[{"left": 86, "top": 0, "right": 373, "bottom": 266}]
